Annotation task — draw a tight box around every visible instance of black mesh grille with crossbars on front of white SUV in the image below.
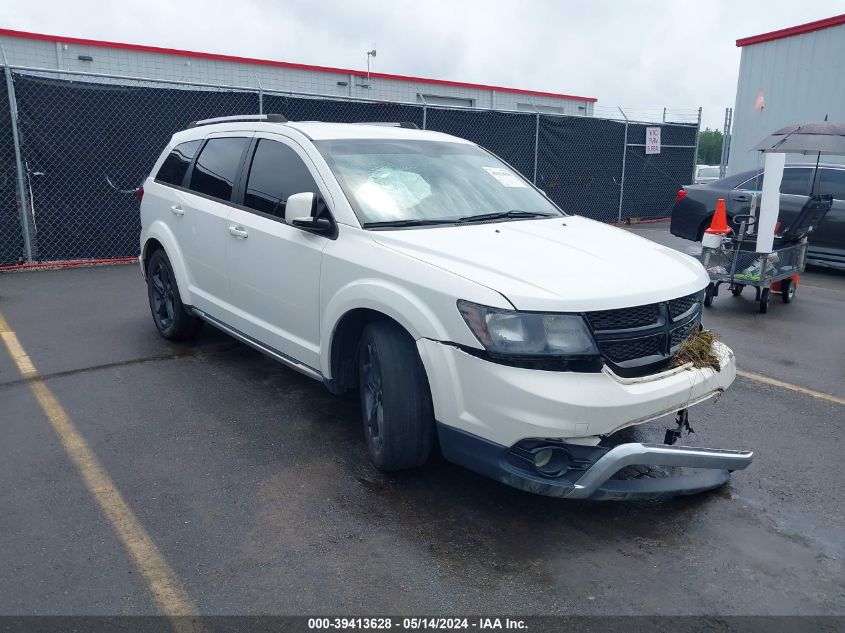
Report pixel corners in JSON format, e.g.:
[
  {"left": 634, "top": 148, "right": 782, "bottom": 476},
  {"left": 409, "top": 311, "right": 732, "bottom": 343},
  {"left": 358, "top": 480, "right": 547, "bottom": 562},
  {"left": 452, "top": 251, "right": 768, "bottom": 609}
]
[{"left": 585, "top": 293, "right": 702, "bottom": 376}]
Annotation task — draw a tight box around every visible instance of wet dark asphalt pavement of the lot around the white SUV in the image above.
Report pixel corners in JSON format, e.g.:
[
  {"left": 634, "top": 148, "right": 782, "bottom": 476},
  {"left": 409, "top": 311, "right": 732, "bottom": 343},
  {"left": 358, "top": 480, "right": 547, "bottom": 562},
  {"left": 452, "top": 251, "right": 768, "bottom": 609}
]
[{"left": 0, "top": 224, "right": 845, "bottom": 615}]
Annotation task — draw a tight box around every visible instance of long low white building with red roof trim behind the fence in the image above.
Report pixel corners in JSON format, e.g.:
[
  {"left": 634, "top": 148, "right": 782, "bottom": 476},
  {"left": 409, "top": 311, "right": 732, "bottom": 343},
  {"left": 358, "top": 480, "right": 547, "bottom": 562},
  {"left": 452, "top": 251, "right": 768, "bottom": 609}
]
[{"left": 0, "top": 29, "right": 596, "bottom": 116}]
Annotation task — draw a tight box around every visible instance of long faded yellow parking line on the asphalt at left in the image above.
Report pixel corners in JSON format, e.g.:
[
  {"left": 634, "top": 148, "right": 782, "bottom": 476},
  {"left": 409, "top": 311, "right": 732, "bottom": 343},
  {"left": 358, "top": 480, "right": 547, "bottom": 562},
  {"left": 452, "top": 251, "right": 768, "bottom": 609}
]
[{"left": 0, "top": 314, "right": 198, "bottom": 631}]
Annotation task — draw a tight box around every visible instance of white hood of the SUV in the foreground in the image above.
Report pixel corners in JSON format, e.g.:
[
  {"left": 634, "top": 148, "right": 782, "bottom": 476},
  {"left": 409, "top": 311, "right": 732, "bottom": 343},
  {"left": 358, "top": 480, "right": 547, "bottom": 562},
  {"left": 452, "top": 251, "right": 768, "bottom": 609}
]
[{"left": 373, "top": 216, "right": 709, "bottom": 312}]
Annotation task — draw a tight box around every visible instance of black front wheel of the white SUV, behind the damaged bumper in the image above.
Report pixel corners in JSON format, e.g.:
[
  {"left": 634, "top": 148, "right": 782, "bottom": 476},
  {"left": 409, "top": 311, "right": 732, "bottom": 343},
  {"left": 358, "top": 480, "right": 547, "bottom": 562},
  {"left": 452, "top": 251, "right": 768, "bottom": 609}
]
[{"left": 358, "top": 320, "right": 435, "bottom": 471}]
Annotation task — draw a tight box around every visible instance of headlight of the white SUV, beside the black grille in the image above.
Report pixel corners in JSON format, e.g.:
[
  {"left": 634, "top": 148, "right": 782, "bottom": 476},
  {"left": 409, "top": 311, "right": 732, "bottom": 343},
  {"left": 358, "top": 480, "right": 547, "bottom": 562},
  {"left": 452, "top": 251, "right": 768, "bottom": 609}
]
[{"left": 458, "top": 299, "right": 599, "bottom": 357}]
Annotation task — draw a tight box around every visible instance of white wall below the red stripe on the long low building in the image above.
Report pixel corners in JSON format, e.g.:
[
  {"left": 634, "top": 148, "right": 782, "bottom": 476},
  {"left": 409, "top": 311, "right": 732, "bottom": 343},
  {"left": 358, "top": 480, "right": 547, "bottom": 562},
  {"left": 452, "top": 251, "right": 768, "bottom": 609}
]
[{"left": 0, "top": 35, "right": 593, "bottom": 116}]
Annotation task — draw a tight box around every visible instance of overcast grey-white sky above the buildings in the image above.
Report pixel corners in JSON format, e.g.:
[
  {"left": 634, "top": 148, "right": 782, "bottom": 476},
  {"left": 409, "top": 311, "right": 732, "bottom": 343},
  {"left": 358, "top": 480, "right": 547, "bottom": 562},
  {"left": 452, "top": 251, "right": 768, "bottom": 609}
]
[{"left": 0, "top": 0, "right": 845, "bottom": 128}]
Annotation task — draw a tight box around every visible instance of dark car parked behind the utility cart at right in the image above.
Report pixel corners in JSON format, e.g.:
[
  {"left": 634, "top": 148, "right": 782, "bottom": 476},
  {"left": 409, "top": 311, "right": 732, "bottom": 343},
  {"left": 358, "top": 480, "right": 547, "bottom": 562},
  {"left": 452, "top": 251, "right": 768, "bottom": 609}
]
[{"left": 670, "top": 163, "right": 845, "bottom": 270}]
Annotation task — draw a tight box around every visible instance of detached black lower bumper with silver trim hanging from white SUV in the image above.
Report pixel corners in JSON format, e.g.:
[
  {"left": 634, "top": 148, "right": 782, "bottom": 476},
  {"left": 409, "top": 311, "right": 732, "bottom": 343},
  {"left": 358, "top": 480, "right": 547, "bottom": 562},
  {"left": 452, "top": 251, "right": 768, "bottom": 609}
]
[{"left": 438, "top": 425, "right": 753, "bottom": 500}]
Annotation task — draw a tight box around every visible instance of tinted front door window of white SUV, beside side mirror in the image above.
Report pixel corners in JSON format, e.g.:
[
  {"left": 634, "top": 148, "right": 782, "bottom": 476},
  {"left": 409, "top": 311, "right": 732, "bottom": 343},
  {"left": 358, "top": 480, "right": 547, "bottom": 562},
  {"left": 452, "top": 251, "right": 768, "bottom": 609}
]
[{"left": 244, "top": 139, "right": 318, "bottom": 218}]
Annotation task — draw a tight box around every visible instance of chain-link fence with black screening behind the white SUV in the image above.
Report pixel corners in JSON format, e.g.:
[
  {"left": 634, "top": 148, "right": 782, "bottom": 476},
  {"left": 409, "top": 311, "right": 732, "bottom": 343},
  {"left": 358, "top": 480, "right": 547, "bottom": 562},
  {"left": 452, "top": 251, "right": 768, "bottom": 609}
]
[{"left": 0, "top": 68, "right": 698, "bottom": 266}]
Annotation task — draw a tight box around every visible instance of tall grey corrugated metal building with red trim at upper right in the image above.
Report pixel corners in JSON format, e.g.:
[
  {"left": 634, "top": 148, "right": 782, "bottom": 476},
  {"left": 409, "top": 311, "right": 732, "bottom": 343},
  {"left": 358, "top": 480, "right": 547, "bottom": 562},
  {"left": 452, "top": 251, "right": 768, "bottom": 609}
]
[{"left": 728, "top": 14, "right": 845, "bottom": 174}]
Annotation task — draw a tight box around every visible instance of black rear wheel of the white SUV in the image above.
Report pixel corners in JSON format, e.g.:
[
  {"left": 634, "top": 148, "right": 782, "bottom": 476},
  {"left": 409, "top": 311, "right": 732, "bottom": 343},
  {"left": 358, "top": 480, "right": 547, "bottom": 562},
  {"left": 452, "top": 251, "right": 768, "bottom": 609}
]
[{"left": 147, "top": 249, "right": 203, "bottom": 341}]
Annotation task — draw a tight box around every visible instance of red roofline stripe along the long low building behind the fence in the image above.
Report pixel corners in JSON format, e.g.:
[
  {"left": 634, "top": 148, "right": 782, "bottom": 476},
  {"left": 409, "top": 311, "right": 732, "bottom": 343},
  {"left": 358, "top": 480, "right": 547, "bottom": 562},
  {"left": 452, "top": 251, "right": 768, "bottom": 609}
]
[{"left": 0, "top": 29, "right": 598, "bottom": 103}]
